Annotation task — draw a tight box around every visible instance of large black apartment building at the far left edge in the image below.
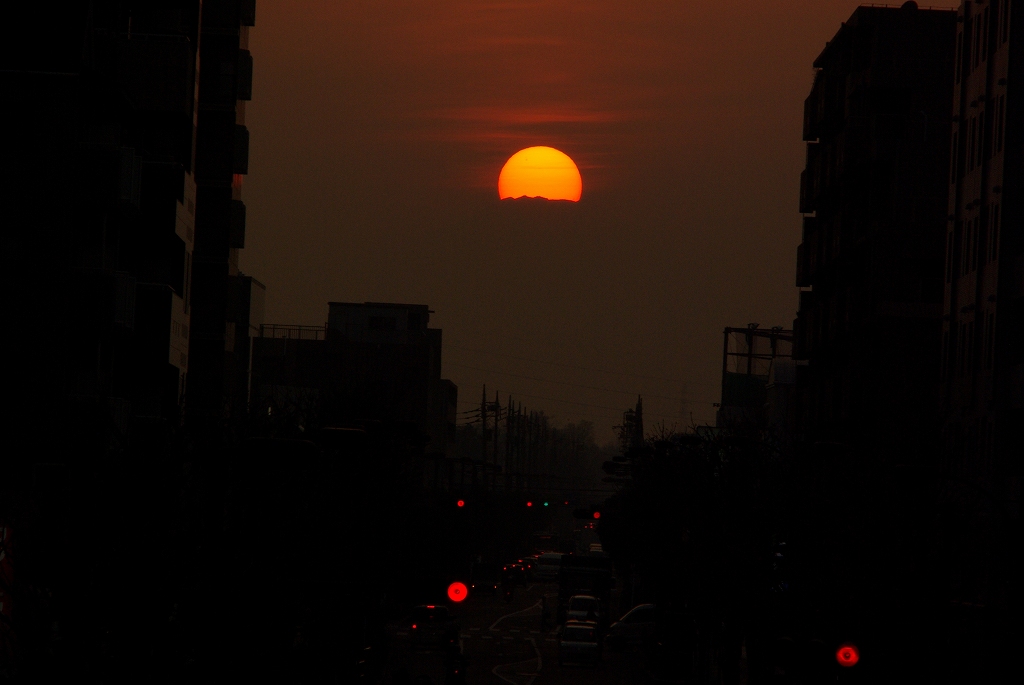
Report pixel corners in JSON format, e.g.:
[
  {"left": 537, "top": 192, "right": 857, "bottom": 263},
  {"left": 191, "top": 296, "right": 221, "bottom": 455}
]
[{"left": 0, "top": 0, "right": 202, "bottom": 459}]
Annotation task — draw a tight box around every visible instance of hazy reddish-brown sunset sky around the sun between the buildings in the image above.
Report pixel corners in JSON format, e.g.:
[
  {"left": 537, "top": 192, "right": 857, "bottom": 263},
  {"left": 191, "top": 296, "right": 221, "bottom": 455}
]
[{"left": 242, "top": 0, "right": 957, "bottom": 440}]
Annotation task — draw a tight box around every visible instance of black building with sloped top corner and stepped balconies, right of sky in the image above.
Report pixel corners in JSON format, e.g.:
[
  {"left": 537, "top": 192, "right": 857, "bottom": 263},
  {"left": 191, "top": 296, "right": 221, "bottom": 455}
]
[{"left": 794, "top": 2, "right": 956, "bottom": 462}]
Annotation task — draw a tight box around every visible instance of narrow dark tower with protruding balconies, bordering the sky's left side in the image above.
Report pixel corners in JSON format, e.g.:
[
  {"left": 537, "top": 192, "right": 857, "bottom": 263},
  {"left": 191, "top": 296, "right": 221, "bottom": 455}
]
[{"left": 187, "top": 0, "right": 262, "bottom": 425}]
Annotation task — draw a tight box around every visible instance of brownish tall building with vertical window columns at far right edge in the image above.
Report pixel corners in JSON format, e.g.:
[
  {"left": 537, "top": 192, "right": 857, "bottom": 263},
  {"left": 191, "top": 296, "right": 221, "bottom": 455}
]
[{"left": 941, "top": 0, "right": 1024, "bottom": 647}]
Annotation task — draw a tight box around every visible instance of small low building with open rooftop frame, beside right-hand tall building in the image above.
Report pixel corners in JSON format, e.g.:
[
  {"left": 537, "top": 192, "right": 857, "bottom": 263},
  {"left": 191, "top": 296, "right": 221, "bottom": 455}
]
[{"left": 715, "top": 324, "right": 793, "bottom": 428}]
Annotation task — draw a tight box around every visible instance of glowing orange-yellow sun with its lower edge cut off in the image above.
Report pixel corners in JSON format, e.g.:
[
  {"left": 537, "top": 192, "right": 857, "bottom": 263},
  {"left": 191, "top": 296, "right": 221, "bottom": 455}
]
[{"left": 498, "top": 146, "right": 583, "bottom": 202}]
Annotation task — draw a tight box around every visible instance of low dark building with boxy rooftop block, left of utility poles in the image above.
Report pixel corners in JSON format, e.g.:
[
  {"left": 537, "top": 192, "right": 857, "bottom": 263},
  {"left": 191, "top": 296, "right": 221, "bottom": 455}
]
[{"left": 252, "top": 302, "right": 458, "bottom": 456}]
